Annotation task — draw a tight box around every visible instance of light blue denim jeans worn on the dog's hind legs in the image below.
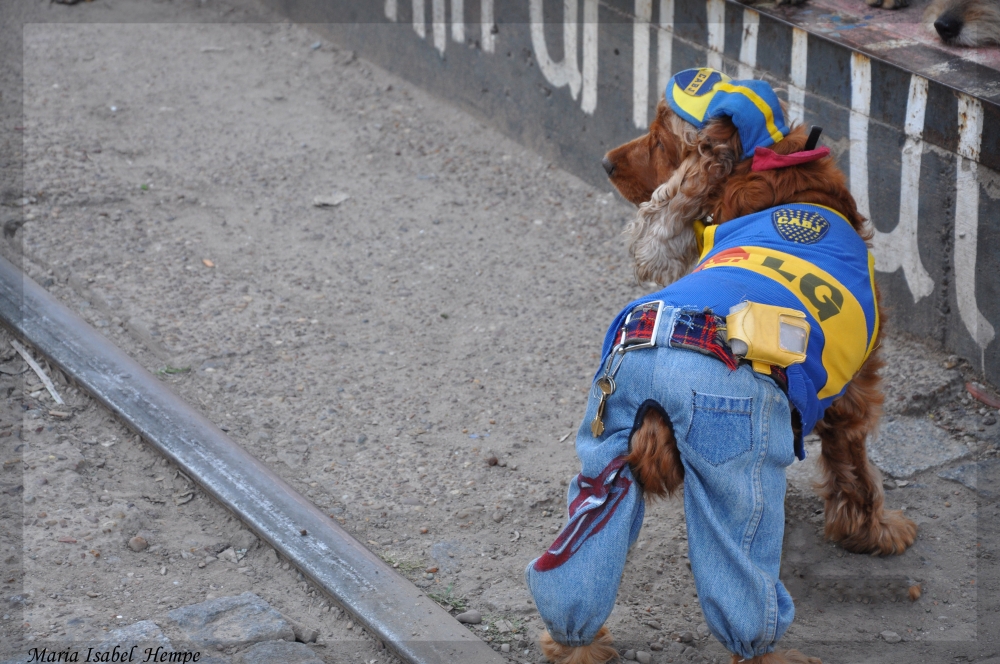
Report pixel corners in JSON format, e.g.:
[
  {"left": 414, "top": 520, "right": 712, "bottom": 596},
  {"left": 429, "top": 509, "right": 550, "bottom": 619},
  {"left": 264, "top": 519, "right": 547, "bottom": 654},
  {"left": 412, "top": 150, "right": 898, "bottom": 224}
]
[{"left": 525, "top": 307, "right": 795, "bottom": 658}]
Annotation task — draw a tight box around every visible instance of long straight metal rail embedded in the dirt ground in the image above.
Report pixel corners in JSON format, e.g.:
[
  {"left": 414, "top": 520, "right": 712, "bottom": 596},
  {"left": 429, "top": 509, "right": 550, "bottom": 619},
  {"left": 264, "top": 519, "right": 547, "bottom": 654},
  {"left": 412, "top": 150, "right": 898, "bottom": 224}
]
[{"left": 0, "top": 257, "right": 505, "bottom": 664}]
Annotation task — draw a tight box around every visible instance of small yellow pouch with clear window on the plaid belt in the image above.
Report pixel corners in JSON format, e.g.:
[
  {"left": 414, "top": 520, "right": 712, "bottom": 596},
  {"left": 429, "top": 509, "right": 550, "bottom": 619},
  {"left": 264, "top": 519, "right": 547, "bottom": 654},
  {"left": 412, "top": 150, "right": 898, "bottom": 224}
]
[{"left": 726, "top": 302, "right": 809, "bottom": 374}]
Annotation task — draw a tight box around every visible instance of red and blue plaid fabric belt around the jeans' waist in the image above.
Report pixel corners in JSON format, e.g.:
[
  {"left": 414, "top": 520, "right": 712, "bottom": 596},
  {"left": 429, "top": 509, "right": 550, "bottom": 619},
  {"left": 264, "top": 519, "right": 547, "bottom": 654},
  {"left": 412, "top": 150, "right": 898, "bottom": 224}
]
[{"left": 614, "top": 302, "right": 788, "bottom": 394}]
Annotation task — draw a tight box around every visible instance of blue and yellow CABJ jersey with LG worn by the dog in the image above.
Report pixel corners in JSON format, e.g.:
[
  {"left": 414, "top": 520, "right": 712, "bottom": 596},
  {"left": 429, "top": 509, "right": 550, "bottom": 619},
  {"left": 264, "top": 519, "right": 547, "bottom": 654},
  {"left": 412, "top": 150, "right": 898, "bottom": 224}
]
[{"left": 600, "top": 203, "right": 879, "bottom": 452}]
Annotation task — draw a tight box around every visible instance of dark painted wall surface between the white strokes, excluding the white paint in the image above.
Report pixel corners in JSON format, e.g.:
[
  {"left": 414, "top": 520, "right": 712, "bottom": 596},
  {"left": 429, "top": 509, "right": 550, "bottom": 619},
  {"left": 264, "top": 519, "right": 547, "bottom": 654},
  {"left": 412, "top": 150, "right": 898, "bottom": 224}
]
[{"left": 260, "top": 0, "right": 1000, "bottom": 384}]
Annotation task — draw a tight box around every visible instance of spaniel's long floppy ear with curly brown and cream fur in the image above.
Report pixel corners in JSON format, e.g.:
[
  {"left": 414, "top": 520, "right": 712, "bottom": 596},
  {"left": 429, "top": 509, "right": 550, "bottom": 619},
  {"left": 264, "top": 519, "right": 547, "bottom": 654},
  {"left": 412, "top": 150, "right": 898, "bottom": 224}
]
[{"left": 625, "top": 116, "right": 741, "bottom": 285}]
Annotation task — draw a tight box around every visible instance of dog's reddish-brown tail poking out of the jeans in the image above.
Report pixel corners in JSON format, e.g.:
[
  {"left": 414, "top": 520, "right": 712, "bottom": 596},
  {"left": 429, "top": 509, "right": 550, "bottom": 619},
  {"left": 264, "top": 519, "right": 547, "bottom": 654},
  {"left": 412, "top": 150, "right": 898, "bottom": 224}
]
[{"left": 626, "top": 401, "right": 684, "bottom": 500}]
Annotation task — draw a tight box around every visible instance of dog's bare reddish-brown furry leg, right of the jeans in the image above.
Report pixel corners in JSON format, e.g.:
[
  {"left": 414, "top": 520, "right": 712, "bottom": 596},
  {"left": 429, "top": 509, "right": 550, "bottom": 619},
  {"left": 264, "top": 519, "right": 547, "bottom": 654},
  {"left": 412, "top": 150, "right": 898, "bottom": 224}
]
[{"left": 816, "top": 348, "right": 917, "bottom": 555}]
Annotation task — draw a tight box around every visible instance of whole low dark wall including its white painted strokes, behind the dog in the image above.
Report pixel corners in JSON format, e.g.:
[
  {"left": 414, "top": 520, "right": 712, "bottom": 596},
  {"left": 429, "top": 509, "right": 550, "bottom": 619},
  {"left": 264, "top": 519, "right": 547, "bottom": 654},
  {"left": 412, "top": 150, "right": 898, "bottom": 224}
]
[{"left": 262, "top": 0, "right": 1000, "bottom": 385}]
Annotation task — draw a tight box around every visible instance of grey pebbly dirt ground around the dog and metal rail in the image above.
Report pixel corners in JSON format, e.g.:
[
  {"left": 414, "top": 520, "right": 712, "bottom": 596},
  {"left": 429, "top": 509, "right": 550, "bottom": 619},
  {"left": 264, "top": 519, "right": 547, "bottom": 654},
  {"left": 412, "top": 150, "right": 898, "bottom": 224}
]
[{"left": 0, "top": 0, "right": 1000, "bottom": 663}]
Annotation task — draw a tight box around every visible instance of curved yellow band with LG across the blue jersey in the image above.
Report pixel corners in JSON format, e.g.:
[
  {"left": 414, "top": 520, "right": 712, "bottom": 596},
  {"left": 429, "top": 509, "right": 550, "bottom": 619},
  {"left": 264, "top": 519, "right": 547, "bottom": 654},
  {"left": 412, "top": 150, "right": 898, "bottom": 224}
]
[{"left": 695, "top": 245, "right": 875, "bottom": 399}]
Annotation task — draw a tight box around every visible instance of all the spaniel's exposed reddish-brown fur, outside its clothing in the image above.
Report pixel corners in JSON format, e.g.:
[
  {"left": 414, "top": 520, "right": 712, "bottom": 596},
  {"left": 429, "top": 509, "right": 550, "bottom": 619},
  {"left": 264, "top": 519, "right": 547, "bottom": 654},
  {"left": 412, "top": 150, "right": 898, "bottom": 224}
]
[{"left": 545, "top": 100, "right": 917, "bottom": 664}]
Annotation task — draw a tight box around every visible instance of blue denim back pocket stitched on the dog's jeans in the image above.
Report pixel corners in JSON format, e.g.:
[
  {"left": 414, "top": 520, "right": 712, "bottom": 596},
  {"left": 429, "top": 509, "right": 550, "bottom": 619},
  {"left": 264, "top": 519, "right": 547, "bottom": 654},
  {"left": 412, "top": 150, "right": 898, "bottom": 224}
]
[{"left": 687, "top": 392, "right": 753, "bottom": 466}]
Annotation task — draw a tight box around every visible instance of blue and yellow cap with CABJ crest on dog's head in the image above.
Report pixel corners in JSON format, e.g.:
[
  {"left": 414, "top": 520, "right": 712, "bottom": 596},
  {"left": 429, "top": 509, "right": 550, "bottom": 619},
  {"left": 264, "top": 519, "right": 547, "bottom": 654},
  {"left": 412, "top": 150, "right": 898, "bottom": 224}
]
[{"left": 666, "top": 67, "right": 790, "bottom": 159}]
